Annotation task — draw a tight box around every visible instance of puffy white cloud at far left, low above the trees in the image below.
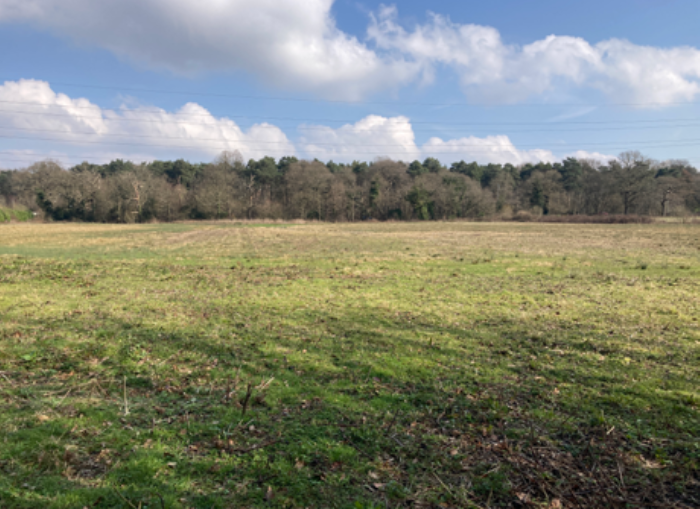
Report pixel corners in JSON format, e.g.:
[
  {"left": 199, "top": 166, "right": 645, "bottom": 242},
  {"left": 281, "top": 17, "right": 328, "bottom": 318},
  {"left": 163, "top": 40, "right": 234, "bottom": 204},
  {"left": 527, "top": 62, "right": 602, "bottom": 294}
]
[{"left": 0, "top": 80, "right": 295, "bottom": 164}]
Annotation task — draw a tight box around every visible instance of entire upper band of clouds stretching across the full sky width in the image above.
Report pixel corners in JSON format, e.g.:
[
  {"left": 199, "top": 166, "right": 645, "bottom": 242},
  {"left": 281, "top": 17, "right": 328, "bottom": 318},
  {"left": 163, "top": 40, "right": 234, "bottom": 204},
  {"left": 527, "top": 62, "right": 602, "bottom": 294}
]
[{"left": 0, "top": 0, "right": 700, "bottom": 106}]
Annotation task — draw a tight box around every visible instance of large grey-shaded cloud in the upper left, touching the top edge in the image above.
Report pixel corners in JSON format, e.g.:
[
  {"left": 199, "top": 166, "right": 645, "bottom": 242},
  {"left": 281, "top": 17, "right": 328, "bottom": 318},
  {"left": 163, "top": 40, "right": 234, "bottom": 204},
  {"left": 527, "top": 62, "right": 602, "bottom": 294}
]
[{"left": 0, "top": 0, "right": 417, "bottom": 100}]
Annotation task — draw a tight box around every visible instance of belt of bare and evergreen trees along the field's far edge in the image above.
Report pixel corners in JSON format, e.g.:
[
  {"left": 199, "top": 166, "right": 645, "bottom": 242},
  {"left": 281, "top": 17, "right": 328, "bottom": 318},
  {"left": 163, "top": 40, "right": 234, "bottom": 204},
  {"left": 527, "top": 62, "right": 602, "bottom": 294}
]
[{"left": 0, "top": 152, "right": 700, "bottom": 223}]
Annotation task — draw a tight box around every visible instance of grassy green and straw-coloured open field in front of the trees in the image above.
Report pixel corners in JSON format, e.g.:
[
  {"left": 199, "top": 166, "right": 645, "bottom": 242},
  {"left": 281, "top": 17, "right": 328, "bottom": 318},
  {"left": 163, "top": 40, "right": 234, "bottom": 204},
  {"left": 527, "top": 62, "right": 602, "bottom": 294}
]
[{"left": 0, "top": 222, "right": 700, "bottom": 509}]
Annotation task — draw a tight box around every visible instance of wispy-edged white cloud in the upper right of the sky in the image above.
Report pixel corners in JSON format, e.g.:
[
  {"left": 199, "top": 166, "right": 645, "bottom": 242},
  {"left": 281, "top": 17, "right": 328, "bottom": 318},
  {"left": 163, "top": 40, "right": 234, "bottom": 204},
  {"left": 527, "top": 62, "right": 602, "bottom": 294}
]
[{"left": 369, "top": 8, "right": 700, "bottom": 106}]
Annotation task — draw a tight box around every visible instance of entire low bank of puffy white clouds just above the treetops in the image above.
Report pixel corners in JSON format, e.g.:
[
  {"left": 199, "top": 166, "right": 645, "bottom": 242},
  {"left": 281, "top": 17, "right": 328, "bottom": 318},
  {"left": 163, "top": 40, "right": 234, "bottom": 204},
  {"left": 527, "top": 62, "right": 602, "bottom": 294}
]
[{"left": 0, "top": 80, "right": 613, "bottom": 167}]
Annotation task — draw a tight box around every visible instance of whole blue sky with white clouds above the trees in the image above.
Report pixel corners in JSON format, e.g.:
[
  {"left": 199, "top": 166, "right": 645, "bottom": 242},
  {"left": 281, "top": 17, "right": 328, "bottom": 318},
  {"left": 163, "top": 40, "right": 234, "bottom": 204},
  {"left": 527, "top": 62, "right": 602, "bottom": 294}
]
[{"left": 0, "top": 0, "right": 700, "bottom": 169}]
